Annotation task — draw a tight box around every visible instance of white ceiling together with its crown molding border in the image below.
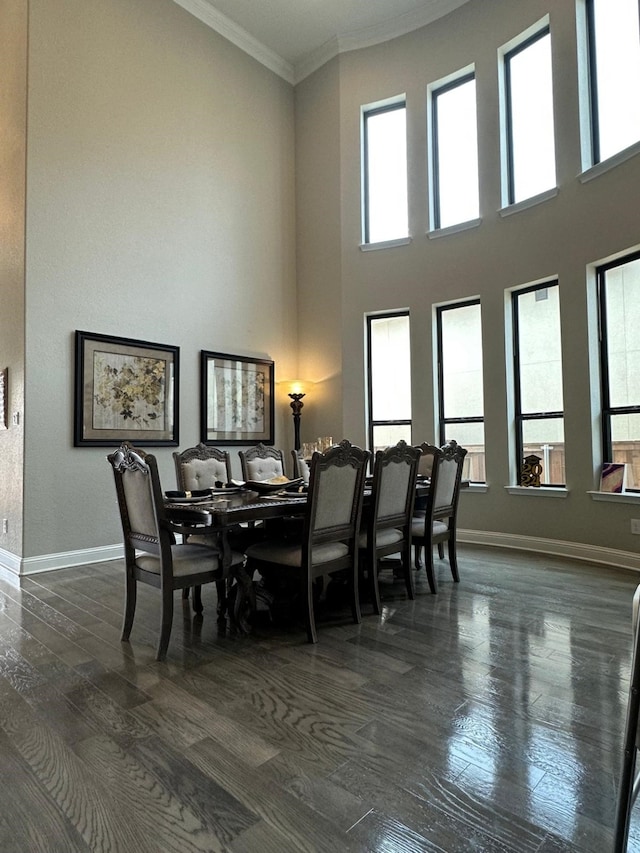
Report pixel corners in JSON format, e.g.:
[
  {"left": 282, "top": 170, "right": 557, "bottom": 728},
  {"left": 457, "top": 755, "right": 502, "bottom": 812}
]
[{"left": 175, "top": 0, "right": 469, "bottom": 83}]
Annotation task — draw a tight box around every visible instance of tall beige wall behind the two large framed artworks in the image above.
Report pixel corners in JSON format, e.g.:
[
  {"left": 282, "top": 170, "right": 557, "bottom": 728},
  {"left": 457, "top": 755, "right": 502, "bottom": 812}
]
[{"left": 18, "top": 0, "right": 297, "bottom": 558}]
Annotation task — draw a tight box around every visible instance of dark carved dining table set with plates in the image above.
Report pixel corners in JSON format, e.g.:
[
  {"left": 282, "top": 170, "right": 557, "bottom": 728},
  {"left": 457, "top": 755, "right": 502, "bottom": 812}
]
[{"left": 164, "top": 477, "right": 429, "bottom": 633}]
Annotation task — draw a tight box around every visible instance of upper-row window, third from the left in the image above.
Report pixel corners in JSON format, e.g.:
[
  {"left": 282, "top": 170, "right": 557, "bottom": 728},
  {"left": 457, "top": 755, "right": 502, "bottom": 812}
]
[{"left": 504, "top": 27, "right": 556, "bottom": 204}]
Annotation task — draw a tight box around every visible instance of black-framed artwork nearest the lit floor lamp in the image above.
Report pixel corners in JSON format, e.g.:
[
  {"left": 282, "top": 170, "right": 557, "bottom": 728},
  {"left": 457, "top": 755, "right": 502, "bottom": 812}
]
[{"left": 200, "top": 350, "right": 274, "bottom": 444}]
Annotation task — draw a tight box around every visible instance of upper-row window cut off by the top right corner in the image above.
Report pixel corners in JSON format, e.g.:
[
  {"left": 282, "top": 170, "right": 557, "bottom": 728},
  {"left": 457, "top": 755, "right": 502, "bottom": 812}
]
[{"left": 586, "top": 0, "right": 640, "bottom": 163}]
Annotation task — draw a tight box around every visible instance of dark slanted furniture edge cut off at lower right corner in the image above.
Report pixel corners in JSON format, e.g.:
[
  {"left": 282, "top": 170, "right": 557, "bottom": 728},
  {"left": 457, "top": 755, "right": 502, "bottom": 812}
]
[{"left": 613, "top": 585, "right": 640, "bottom": 853}]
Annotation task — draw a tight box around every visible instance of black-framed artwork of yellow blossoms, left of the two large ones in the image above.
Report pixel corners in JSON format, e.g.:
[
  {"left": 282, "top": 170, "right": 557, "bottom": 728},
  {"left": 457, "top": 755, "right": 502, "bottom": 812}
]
[{"left": 73, "top": 331, "right": 180, "bottom": 447}]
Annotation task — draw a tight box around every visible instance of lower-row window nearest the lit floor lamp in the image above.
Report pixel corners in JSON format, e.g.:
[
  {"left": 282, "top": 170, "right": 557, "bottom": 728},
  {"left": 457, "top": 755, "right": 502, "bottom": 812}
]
[{"left": 367, "top": 313, "right": 411, "bottom": 453}]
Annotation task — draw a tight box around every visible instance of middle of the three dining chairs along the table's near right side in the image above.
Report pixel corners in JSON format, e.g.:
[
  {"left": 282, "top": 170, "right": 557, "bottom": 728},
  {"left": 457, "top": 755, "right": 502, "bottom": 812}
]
[{"left": 358, "top": 441, "right": 421, "bottom": 613}]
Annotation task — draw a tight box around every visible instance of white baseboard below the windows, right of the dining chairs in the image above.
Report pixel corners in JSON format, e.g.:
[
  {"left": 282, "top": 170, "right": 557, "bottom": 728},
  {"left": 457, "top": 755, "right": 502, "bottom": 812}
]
[{"left": 458, "top": 529, "right": 640, "bottom": 572}]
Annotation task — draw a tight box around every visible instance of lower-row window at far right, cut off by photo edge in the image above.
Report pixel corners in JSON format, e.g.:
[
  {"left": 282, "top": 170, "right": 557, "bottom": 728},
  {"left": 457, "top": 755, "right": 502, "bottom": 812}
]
[{"left": 597, "top": 252, "right": 640, "bottom": 490}]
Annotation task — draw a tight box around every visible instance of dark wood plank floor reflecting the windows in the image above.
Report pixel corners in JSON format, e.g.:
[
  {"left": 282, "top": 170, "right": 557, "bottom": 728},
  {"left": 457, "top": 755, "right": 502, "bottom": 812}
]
[{"left": 0, "top": 547, "right": 640, "bottom": 853}]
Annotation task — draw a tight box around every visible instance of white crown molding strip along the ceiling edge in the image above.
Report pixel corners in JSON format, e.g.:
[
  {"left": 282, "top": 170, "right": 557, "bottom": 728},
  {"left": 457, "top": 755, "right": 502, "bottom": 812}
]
[{"left": 173, "top": 0, "right": 469, "bottom": 85}]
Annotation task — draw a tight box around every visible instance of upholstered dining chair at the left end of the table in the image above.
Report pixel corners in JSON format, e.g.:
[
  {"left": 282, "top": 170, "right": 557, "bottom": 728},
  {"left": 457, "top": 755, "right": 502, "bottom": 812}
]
[{"left": 107, "top": 442, "right": 243, "bottom": 660}]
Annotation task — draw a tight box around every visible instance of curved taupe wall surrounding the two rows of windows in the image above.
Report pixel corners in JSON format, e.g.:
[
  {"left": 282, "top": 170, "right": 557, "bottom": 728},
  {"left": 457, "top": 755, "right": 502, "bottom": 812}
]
[{"left": 297, "top": 0, "right": 640, "bottom": 552}]
